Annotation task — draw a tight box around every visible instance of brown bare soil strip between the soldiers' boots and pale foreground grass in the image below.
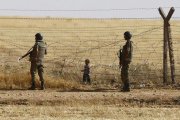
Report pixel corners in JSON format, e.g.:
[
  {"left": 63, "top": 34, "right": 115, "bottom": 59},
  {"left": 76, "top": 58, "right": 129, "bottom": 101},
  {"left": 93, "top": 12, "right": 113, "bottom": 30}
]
[{"left": 0, "top": 89, "right": 180, "bottom": 108}]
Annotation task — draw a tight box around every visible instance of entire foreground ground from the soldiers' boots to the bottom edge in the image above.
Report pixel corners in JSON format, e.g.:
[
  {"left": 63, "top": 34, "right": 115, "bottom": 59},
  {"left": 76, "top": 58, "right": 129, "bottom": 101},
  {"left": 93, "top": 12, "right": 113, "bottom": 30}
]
[{"left": 0, "top": 89, "right": 180, "bottom": 120}]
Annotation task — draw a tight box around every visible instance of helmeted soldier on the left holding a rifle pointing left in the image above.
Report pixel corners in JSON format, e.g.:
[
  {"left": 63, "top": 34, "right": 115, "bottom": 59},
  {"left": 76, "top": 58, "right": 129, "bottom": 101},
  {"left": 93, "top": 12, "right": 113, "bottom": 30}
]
[{"left": 19, "top": 33, "right": 47, "bottom": 90}]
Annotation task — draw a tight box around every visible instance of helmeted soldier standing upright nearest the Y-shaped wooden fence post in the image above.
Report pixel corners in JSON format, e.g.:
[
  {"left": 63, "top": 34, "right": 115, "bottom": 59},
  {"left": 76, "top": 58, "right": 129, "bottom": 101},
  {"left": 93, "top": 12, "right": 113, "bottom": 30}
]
[{"left": 120, "top": 31, "right": 133, "bottom": 92}]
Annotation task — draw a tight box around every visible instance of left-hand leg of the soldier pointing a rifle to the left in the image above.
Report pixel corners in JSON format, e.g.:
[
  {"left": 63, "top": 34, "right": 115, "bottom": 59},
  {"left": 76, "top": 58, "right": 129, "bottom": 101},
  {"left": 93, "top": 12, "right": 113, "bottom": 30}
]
[{"left": 30, "top": 62, "right": 37, "bottom": 90}]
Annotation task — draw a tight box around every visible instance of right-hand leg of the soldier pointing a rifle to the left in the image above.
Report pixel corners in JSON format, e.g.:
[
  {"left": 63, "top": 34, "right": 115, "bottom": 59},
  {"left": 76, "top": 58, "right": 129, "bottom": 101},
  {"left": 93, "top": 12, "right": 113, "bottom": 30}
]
[{"left": 38, "top": 65, "right": 45, "bottom": 90}]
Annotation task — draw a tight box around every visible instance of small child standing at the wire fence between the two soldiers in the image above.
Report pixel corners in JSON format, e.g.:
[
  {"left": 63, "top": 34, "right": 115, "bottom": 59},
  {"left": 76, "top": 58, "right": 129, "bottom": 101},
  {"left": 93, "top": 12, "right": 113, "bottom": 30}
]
[{"left": 81, "top": 59, "right": 91, "bottom": 84}]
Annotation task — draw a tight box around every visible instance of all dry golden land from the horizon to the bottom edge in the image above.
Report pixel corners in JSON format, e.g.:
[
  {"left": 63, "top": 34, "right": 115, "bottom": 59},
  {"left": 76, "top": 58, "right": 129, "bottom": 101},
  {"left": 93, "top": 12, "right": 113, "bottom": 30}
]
[{"left": 0, "top": 17, "right": 180, "bottom": 120}]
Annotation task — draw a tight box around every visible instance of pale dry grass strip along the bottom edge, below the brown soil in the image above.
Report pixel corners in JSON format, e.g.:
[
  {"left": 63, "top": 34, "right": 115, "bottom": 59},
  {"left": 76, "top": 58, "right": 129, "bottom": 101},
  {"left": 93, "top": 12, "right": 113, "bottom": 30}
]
[{"left": 0, "top": 105, "right": 180, "bottom": 120}]
